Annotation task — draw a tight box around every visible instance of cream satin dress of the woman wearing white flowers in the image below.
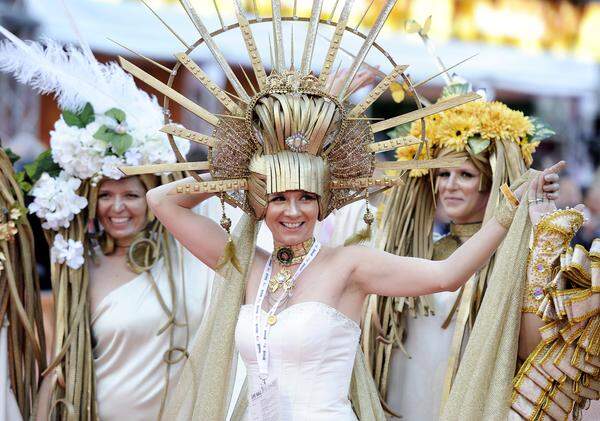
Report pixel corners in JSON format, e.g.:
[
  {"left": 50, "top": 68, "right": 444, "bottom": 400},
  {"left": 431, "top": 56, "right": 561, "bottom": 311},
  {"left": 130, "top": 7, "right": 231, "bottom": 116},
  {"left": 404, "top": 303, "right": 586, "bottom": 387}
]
[{"left": 91, "top": 199, "right": 220, "bottom": 421}]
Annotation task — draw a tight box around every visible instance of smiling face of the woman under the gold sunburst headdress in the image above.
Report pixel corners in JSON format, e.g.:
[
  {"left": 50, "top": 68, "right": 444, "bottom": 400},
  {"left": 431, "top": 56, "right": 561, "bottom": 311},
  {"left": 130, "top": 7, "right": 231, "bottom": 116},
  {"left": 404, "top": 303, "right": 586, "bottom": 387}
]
[{"left": 265, "top": 190, "right": 319, "bottom": 246}]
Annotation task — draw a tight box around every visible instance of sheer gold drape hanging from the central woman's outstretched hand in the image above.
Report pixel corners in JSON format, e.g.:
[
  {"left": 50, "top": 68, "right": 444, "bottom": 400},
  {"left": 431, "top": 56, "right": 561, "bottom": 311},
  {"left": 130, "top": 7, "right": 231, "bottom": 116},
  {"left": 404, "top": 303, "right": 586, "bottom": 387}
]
[{"left": 440, "top": 171, "right": 534, "bottom": 421}]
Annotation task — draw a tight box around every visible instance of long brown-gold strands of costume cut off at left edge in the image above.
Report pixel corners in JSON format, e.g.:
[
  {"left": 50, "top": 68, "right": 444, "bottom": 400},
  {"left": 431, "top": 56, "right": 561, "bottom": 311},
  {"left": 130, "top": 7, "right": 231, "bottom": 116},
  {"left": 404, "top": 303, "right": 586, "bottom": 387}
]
[{"left": 0, "top": 149, "right": 46, "bottom": 421}]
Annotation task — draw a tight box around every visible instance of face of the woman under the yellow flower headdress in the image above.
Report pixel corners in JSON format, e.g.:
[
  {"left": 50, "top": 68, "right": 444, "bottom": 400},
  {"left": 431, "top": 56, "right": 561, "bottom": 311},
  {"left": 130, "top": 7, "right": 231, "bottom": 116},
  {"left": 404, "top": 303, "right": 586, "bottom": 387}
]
[{"left": 437, "top": 159, "right": 490, "bottom": 224}]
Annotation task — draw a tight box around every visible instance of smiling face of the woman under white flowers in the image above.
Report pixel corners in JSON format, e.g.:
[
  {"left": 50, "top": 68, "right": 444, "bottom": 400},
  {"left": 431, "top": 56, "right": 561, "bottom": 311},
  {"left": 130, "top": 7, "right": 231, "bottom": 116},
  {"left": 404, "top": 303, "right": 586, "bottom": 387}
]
[{"left": 96, "top": 177, "right": 148, "bottom": 246}]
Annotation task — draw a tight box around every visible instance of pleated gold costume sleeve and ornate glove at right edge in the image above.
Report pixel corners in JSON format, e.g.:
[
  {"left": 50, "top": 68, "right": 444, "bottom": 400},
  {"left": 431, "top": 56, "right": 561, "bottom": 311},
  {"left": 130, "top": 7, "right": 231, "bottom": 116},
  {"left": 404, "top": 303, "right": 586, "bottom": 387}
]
[{"left": 510, "top": 233, "right": 600, "bottom": 421}]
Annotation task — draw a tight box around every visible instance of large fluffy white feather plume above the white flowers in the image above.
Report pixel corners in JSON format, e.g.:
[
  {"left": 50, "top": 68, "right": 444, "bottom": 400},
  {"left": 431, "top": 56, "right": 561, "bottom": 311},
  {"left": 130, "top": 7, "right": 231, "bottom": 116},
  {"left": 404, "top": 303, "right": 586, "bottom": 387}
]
[{"left": 0, "top": 25, "right": 162, "bottom": 128}]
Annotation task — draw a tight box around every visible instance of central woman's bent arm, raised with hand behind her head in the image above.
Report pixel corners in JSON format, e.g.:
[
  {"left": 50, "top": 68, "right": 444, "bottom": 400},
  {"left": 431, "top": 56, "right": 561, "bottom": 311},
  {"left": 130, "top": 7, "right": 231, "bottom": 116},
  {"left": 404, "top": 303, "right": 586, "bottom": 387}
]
[{"left": 146, "top": 177, "right": 227, "bottom": 269}]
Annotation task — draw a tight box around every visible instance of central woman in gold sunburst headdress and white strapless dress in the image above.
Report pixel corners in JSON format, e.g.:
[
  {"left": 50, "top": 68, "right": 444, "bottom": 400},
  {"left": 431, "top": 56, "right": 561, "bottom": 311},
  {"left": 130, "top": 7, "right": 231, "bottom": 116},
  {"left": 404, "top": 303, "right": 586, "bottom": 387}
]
[{"left": 121, "top": 0, "right": 561, "bottom": 420}]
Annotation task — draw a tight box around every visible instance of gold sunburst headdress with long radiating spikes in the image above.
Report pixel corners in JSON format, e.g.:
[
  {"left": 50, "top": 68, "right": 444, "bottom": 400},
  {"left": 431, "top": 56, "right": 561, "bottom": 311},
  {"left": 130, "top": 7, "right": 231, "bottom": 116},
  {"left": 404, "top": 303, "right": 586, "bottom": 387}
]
[{"left": 121, "top": 0, "right": 478, "bottom": 226}]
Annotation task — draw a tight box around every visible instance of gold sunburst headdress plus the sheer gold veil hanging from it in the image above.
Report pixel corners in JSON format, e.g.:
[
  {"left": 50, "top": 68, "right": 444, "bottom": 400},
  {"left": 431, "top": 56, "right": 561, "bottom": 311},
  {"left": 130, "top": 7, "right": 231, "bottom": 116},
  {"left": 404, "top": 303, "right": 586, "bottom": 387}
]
[{"left": 121, "top": 0, "right": 479, "bottom": 421}]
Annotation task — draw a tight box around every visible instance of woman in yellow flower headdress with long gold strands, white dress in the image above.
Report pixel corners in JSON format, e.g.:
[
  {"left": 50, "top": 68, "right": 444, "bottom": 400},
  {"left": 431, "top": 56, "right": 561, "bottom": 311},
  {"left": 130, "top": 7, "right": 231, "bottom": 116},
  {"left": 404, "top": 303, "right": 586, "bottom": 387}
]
[{"left": 363, "top": 69, "right": 558, "bottom": 419}]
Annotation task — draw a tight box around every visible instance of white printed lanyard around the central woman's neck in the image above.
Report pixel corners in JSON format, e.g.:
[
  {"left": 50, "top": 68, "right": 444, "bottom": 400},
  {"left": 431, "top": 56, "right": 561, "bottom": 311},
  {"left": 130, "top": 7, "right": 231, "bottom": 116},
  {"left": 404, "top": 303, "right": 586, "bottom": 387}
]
[{"left": 254, "top": 240, "right": 321, "bottom": 381}]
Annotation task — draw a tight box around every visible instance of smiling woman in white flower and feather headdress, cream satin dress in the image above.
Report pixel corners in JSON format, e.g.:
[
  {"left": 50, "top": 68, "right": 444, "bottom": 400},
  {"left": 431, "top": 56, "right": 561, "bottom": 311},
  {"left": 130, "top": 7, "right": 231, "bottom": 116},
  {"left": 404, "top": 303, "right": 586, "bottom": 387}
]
[{"left": 0, "top": 27, "right": 229, "bottom": 420}]
